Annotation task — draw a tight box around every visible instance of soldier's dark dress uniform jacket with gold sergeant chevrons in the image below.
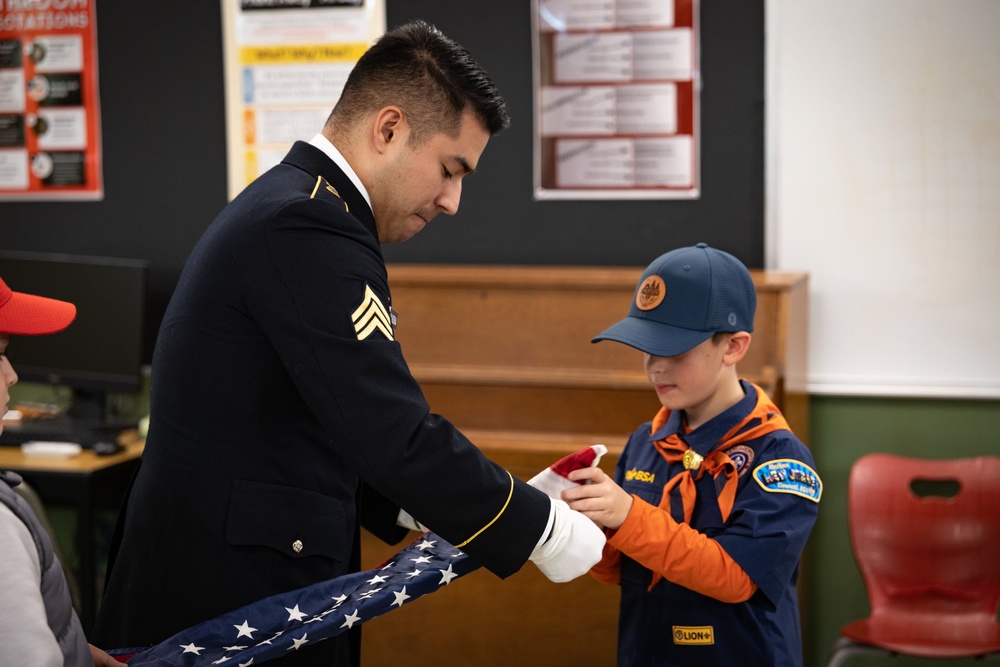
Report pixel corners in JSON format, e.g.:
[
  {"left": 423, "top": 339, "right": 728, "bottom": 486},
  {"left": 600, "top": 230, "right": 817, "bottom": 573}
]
[{"left": 93, "top": 142, "right": 550, "bottom": 665}]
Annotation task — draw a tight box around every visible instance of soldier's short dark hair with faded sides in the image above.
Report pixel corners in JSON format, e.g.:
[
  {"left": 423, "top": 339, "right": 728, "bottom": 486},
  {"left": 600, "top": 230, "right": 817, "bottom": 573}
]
[{"left": 327, "top": 20, "right": 510, "bottom": 143}]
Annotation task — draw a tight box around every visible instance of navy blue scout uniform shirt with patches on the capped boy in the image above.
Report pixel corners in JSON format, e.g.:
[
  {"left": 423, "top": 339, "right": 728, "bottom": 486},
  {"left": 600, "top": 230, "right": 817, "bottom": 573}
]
[{"left": 615, "top": 380, "right": 822, "bottom": 667}]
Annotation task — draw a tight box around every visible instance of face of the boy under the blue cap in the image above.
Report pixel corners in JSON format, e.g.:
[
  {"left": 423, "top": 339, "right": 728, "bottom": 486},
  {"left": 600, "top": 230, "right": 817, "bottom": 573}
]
[{"left": 643, "top": 336, "right": 736, "bottom": 427}]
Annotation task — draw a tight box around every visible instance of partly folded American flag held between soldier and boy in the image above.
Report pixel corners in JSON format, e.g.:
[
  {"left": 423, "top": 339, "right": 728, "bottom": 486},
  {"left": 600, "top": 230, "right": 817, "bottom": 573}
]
[{"left": 108, "top": 445, "right": 607, "bottom": 667}]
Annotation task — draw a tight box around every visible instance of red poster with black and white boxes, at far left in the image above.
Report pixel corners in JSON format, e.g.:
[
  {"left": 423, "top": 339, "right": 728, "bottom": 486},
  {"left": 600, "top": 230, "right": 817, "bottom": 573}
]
[{"left": 0, "top": 0, "right": 104, "bottom": 200}]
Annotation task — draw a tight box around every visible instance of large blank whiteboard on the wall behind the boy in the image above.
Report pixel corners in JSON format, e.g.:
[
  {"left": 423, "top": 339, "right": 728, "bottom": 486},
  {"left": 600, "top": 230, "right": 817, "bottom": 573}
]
[{"left": 765, "top": 0, "right": 1000, "bottom": 398}]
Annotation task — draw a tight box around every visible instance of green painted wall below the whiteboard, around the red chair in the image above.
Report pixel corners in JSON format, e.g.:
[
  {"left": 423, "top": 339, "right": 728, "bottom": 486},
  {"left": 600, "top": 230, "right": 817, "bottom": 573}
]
[{"left": 801, "top": 396, "right": 1000, "bottom": 667}]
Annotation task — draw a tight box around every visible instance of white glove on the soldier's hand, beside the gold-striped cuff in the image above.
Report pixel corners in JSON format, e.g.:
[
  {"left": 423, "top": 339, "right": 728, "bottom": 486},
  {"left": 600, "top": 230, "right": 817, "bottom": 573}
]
[{"left": 529, "top": 498, "right": 605, "bottom": 583}]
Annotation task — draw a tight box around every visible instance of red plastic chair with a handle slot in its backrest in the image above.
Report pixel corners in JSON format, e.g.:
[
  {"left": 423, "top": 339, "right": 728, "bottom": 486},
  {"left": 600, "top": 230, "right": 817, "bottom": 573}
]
[{"left": 828, "top": 454, "right": 1000, "bottom": 667}]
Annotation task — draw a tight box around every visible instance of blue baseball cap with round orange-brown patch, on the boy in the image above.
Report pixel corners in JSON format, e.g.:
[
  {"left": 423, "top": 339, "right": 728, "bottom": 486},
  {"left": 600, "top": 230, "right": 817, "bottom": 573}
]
[{"left": 591, "top": 243, "right": 757, "bottom": 357}]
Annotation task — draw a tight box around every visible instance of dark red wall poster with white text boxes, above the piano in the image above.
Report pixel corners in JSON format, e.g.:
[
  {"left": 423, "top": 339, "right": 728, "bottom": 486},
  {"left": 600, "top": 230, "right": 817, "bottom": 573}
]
[{"left": 532, "top": 0, "right": 701, "bottom": 199}]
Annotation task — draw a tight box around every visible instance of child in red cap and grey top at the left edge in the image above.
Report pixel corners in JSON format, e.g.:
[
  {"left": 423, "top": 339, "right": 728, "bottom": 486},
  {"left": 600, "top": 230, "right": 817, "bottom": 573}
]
[{"left": 0, "top": 279, "right": 119, "bottom": 667}]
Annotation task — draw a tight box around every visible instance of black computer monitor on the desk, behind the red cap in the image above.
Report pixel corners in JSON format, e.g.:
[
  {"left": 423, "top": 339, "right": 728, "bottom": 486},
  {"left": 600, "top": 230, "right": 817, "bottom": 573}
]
[{"left": 0, "top": 251, "right": 149, "bottom": 422}]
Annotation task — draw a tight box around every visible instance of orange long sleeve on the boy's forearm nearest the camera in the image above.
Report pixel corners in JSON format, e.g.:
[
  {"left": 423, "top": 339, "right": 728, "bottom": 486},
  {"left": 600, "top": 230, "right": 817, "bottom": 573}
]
[{"left": 591, "top": 495, "right": 757, "bottom": 603}]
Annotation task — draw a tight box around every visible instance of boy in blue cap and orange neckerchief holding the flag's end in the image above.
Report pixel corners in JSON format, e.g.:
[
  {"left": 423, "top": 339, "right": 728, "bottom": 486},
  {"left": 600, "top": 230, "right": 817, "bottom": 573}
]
[{"left": 562, "top": 243, "right": 823, "bottom": 667}]
